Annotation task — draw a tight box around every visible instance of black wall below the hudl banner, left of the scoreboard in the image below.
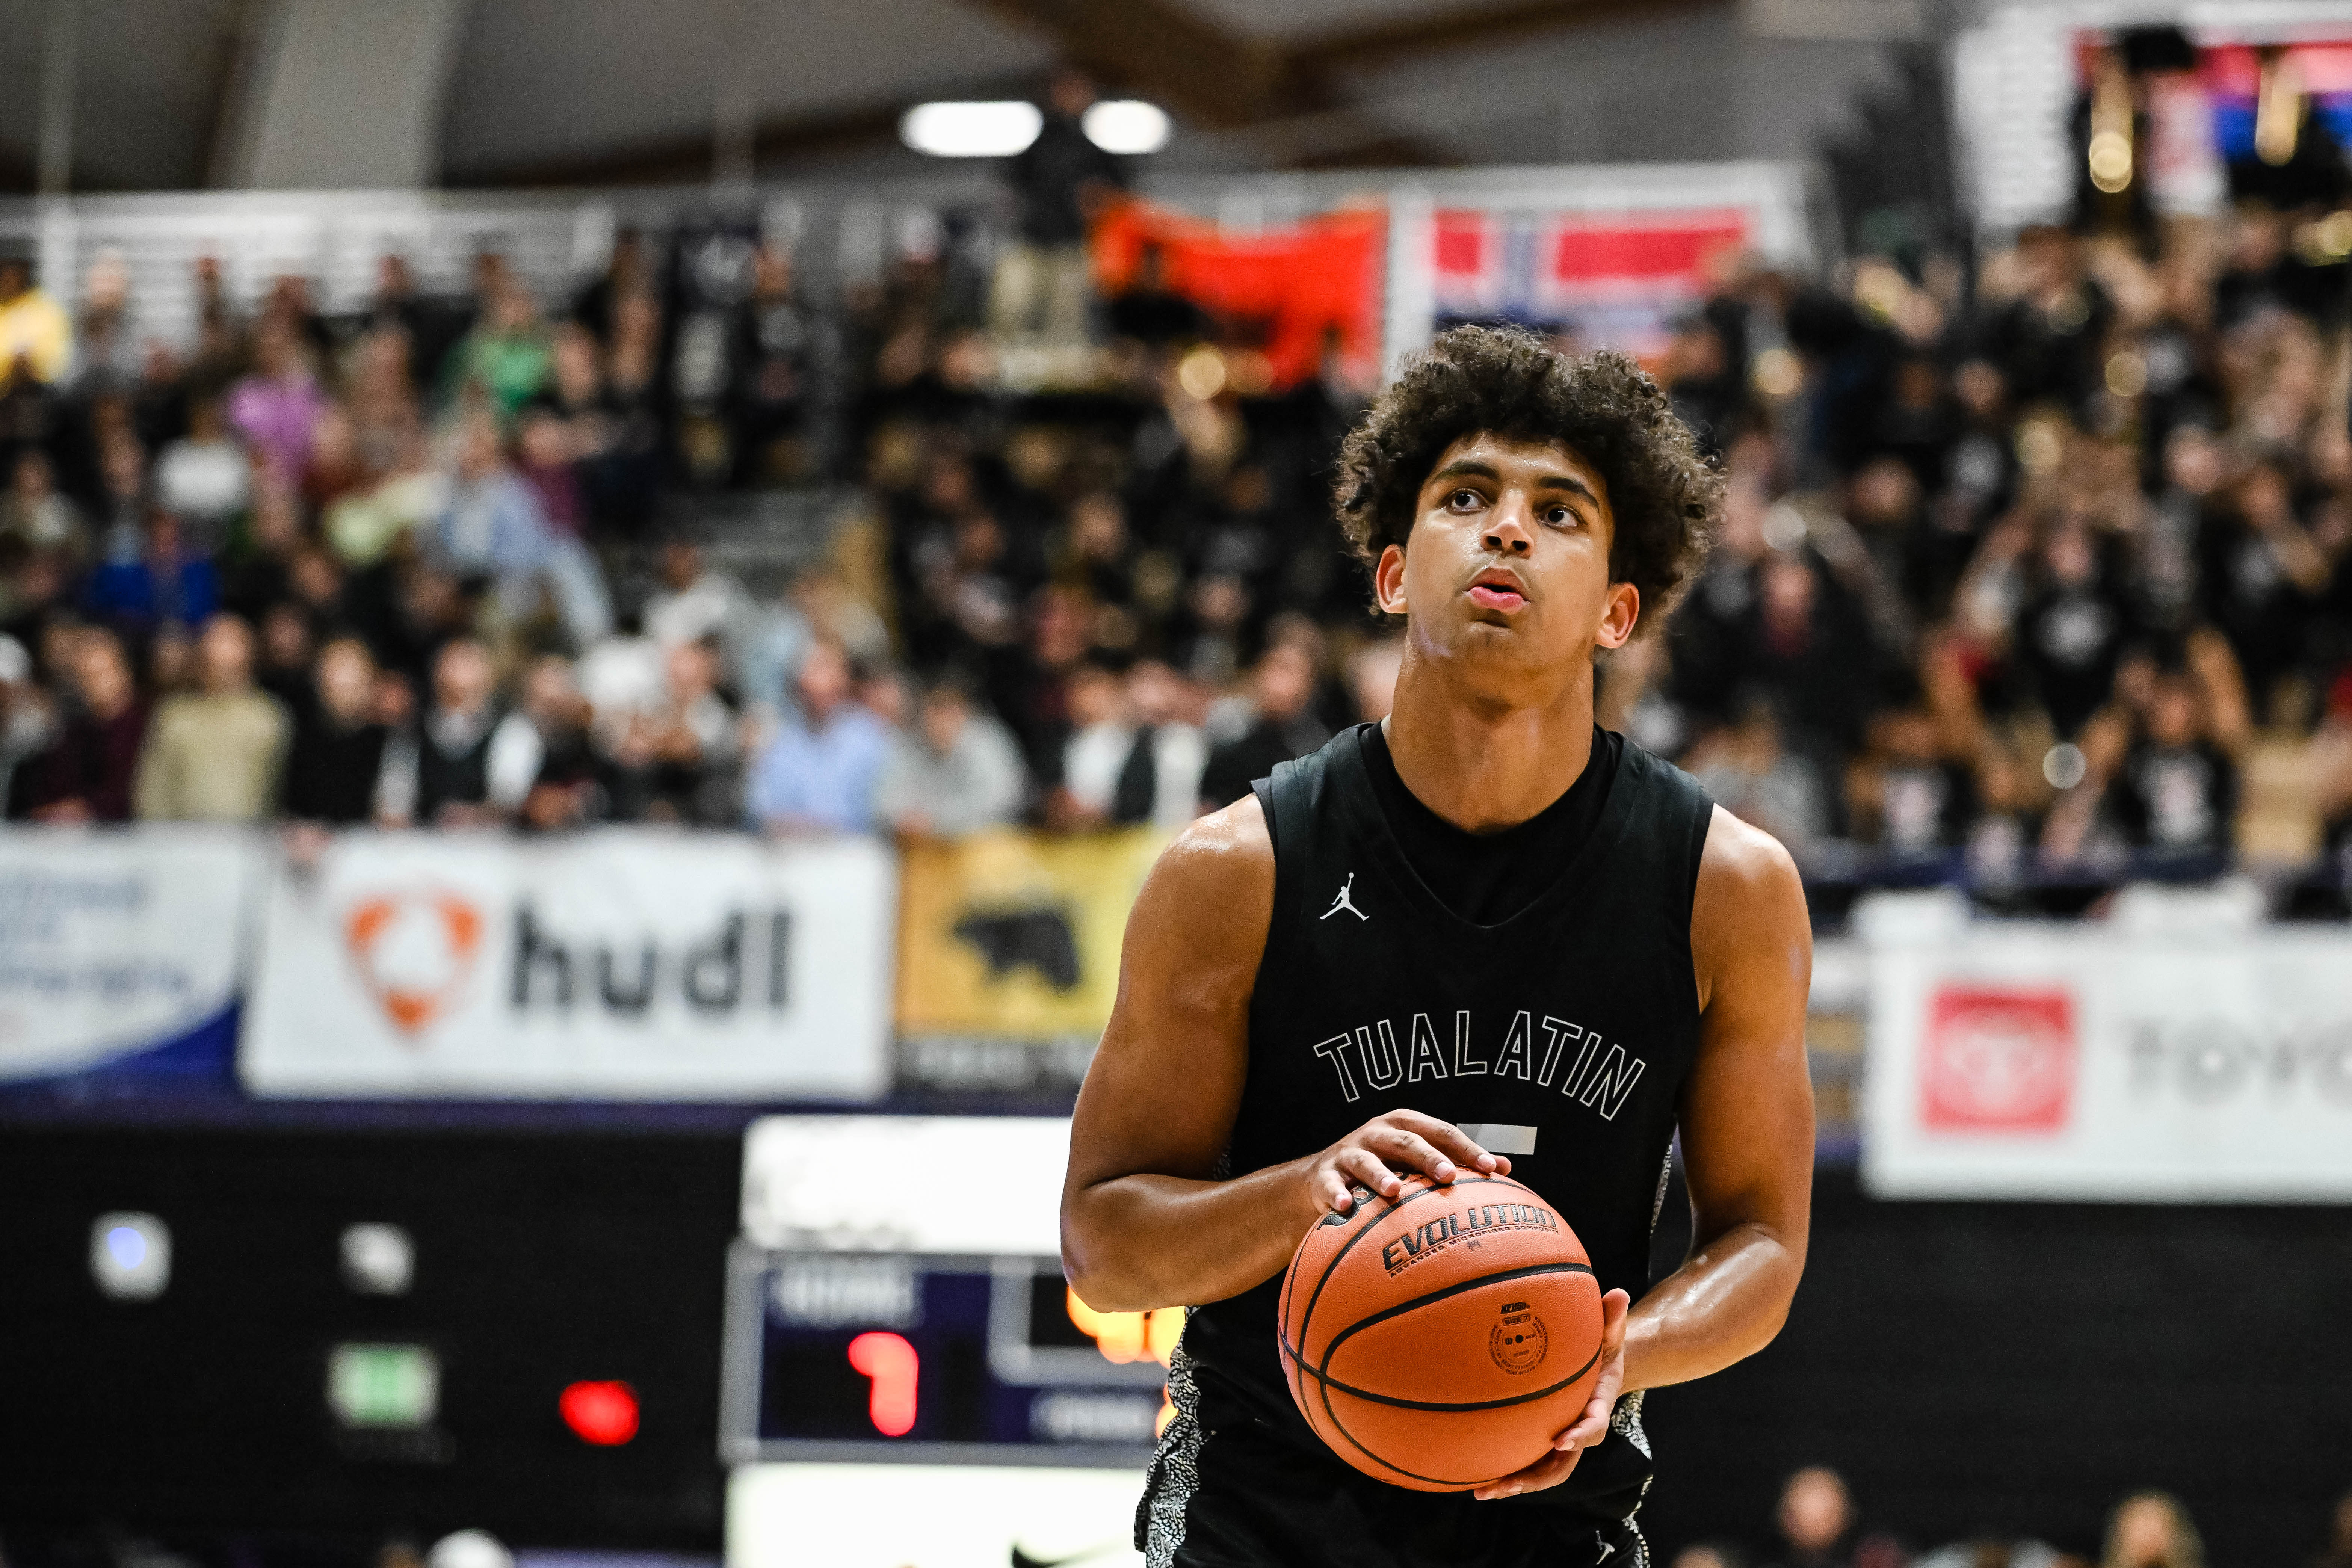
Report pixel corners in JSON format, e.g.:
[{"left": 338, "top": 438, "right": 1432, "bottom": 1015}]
[{"left": 0, "top": 1128, "right": 741, "bottom": 1556}]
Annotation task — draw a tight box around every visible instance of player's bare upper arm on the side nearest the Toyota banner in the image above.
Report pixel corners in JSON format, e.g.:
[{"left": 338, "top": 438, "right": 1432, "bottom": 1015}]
[{"left": 1682, "top": 811, "right": 1813, "bottom": 1246}]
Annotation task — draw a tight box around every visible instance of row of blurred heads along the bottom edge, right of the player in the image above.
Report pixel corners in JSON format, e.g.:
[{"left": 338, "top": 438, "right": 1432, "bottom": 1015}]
[{"left": 1672, "top": 1465, "right": 2352, "bottom": 1568}]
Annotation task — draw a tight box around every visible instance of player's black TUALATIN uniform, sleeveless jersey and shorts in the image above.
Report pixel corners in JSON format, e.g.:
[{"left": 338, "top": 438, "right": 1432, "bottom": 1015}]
[{"left": 1145, "top": 729, "right": 1712, "bottom": 1561}]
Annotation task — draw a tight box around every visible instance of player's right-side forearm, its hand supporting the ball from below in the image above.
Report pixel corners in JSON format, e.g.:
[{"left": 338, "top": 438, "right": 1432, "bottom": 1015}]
[{"left": 1625, "top": 1220, "right": 1804, "bottom": 1392}]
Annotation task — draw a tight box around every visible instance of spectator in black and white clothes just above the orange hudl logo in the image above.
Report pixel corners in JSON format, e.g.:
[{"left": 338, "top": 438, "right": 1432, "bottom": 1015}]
[{"left": 376, "top": 637, "right": 546, "bottom": 828}]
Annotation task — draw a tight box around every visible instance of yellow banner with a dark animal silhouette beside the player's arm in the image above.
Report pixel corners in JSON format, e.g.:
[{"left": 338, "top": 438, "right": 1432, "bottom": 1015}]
[{"left": 899, "top": 828, "right": 1166, "bottom": 1039}]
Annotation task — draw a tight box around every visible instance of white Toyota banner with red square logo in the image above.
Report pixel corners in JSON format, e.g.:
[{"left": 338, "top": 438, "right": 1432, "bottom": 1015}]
[{"left": 1863, "top": 924, "right": 2352, "bottom": 1201}]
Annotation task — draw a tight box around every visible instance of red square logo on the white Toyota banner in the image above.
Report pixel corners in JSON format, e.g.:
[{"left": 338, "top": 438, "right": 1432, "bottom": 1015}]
[{"left": 1919, "top": 985, "right": 2077, "bottom": 1133}]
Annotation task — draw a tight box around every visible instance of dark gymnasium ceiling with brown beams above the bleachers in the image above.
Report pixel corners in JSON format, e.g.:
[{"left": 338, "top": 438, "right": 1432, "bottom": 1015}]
[{"left": 0, "top": 0, "right": 1917, "bottom": 190}]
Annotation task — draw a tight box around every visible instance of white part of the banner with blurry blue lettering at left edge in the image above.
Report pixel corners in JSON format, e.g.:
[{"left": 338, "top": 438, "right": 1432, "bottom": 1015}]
[{"left": 0, "top": 828, "right": 263, "bottom": 1082}]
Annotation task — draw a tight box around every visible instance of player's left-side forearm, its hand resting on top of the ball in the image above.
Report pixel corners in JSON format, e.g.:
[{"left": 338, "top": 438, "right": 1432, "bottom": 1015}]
[{"left": 1061, "top": 1159, "right": 1322, "bottom": 1312}]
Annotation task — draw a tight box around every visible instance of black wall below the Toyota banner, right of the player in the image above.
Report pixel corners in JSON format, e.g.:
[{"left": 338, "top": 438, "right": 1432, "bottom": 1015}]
[{"left": 1644, "top": 1171, "right": 2352, "bottom": 1568}]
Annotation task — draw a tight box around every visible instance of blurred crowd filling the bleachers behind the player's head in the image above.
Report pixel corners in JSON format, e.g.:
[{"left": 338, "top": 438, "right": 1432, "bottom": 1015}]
[{"left": 0, "top": 171, "right": 2352, "bottom": 888}]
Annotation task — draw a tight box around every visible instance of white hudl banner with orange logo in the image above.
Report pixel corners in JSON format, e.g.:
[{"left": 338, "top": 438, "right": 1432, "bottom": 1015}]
[{"left": 240, "top": 828, "right": 896, "bottom": 1100}]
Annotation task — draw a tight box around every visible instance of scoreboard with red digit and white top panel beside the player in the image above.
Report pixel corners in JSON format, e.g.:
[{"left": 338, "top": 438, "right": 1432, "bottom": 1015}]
[{"left": 720, "top": 1116, "right": 1183, "bottom": 1467}]
